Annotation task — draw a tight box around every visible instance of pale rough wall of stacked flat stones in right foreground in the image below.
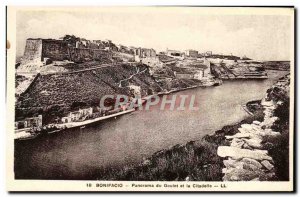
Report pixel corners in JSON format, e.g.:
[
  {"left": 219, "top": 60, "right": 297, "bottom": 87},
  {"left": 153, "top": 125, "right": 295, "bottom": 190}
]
[{"left": 217, "top": 76, "right": 289, "bottom": 181}]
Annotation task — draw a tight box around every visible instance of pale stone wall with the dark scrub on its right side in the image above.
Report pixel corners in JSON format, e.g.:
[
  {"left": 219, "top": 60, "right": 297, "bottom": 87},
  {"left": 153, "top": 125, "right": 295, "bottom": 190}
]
[{"left": 218, "top": 75, "right": 290, "bottom": 181}]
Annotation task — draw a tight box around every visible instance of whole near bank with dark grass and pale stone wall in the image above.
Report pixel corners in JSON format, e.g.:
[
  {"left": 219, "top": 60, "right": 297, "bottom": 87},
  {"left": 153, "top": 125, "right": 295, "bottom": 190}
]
[{"left": 93, "top": 75, "right": 290, "bottom": 181}]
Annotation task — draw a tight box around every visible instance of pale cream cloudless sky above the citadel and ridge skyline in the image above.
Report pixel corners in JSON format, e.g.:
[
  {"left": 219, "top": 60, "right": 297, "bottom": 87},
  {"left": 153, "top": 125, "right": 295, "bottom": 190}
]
[{"left": 17, "top": 7, "right": 293, "bottom": 60}]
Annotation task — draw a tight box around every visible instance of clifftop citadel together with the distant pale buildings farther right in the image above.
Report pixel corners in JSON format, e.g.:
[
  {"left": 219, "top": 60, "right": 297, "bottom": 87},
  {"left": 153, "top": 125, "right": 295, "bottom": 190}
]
[{"left": 21, "top": 35, "right": 219, "bottom": 72}]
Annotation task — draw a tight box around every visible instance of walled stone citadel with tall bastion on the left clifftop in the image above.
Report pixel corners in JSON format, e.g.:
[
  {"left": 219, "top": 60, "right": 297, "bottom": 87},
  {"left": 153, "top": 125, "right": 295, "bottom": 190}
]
[{"left": 21, "top": 36, "right": 156, "bottom": 65}]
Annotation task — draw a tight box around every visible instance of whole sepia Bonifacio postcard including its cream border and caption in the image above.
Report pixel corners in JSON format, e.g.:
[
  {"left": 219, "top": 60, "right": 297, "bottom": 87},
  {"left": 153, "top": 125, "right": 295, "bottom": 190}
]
[{"left": 6, "top": 6, "right": 295, "bottom": 192}]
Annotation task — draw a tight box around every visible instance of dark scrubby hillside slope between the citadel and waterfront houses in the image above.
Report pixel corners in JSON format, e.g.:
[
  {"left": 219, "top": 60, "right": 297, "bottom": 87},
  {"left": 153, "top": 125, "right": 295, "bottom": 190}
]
[{"left": 16, "top": 64, "right": 161, "bottom": 124}]
